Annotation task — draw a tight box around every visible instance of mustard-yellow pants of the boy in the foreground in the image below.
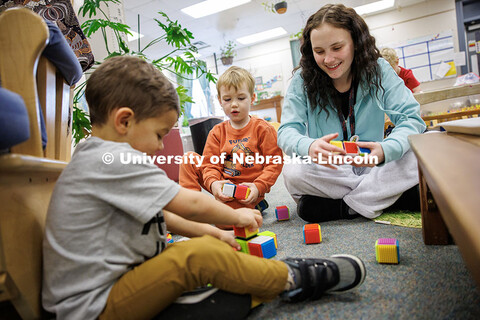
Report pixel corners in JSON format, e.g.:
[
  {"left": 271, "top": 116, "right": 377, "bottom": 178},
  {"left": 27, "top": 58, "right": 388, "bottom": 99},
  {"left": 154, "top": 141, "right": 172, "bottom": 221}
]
[{"left": 100, "top": 236, "right": 288, "bottom": 319}]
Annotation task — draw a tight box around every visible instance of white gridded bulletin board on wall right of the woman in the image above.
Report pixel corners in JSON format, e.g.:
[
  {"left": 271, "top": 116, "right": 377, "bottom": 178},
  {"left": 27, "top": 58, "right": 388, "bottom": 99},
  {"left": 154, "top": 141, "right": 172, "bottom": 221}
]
[{"left": 388, "top": 30, "right": 457, "bottom": 82}]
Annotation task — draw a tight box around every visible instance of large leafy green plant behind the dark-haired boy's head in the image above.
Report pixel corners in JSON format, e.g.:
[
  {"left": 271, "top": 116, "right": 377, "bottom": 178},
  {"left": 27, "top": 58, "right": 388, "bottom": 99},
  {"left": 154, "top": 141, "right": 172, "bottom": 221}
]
[{"left": 72, "top": 0, "right": 216, "bottom": 145}]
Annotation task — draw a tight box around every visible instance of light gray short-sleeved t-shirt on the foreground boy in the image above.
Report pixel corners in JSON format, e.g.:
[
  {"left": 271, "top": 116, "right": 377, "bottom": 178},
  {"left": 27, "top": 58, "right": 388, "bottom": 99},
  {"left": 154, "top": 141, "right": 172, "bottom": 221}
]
[{"left": 42, "top": 137, "right": 180, "bottom": 319}]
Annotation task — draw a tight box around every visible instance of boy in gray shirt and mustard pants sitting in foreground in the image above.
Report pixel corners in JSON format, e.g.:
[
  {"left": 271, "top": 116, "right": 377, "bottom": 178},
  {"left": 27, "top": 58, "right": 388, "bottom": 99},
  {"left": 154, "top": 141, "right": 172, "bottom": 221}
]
[{"left": 42, "top": 56, "right": 365, "bottom": 319}]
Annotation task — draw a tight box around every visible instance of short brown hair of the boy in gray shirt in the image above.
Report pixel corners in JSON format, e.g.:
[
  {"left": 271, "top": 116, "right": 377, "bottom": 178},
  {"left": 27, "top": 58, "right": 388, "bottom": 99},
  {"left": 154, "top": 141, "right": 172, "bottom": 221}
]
[{"left": 85, "top": 56, "right": 180, "bottom": 125}]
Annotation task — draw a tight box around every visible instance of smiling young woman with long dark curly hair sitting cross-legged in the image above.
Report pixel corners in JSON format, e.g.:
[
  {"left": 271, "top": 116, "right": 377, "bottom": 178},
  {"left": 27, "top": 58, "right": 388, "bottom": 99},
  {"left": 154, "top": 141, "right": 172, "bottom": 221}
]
[{"left": 278, "top": 4, "right": 425, "bottom": 222}]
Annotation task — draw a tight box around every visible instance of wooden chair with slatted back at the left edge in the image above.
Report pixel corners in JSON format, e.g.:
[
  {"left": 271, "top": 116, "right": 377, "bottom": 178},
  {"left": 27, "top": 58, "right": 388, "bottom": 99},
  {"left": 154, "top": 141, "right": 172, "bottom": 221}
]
[{"left": 0, "top": 9, "right": 72, "bottom": 319}]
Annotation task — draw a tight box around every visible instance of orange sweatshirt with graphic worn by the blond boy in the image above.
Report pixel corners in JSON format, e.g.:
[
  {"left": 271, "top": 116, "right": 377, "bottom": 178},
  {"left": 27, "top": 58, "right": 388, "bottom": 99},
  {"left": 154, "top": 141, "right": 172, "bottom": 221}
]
[{"left": 202, "top": 117, "right": 283, "bottom": 198}]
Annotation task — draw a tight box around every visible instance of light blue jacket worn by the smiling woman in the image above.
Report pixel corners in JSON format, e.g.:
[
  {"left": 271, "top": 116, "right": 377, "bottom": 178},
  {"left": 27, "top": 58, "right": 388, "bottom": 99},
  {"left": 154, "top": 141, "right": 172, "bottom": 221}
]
[{"left": 278, "top": 58, "right": 425, "bottom": 163}]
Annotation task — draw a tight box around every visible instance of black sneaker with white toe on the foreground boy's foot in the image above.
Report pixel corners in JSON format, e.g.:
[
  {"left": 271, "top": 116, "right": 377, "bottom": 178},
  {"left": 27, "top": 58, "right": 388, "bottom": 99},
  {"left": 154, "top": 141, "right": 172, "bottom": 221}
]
[{"left": 282, "top": 254, "right": 366, "bottom": 302}]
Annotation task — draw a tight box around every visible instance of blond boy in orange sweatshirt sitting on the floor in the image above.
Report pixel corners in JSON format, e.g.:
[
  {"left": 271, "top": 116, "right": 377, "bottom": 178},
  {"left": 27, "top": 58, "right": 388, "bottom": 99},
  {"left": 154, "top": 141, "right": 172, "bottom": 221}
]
[{"left": 179, "top": 66, "right": 283, "bottom": 214}]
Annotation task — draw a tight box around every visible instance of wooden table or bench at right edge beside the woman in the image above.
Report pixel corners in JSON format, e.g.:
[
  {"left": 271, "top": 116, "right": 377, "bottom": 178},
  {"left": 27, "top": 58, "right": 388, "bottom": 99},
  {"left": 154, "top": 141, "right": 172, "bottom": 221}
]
[{"left": 409, "top": 132, "right": 480, "bottom": 287}]
